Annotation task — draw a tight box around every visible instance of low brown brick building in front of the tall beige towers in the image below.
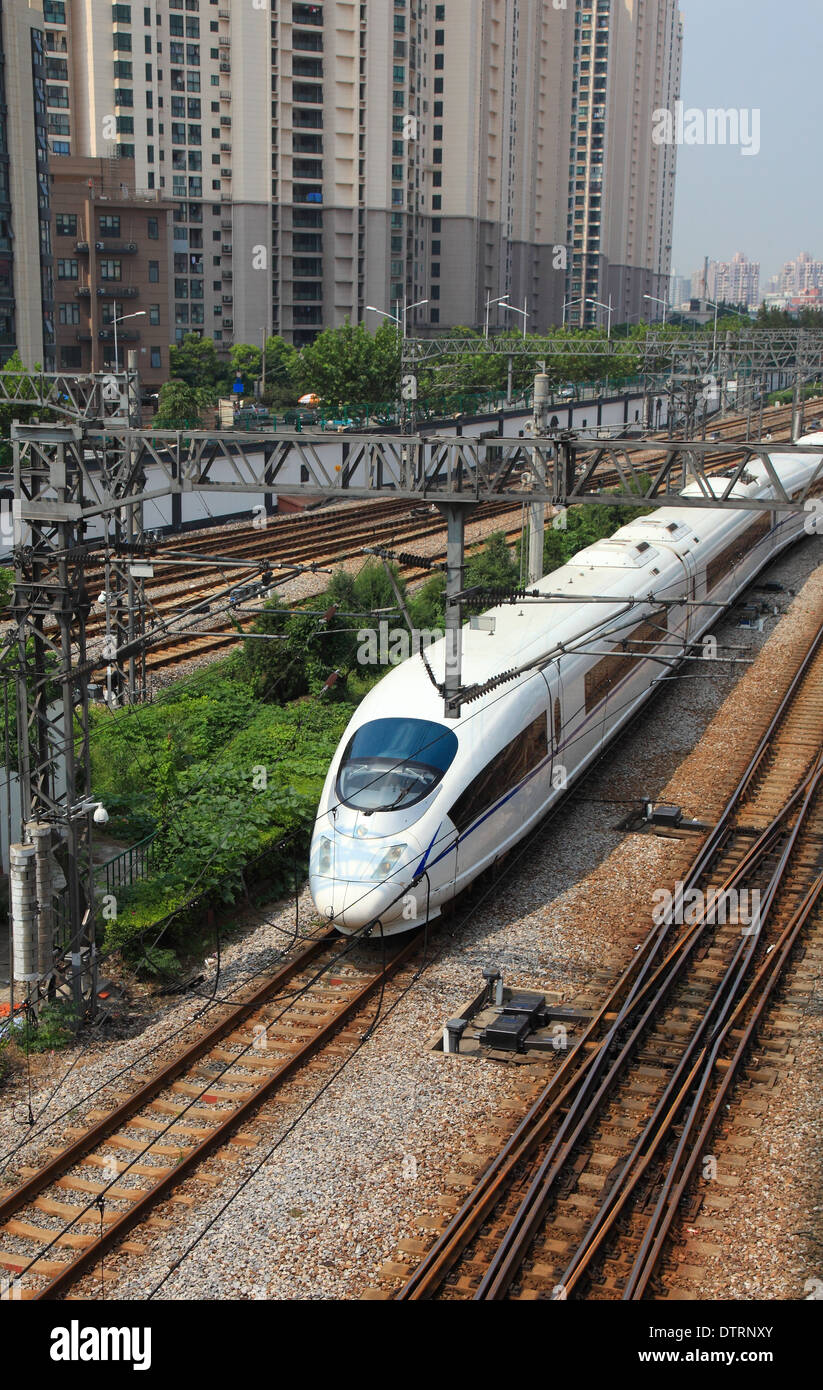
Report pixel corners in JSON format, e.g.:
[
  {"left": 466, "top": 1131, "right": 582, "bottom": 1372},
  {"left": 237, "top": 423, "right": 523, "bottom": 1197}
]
[{"left": 51, "top": 156, "right": 172, "bottom": 391}]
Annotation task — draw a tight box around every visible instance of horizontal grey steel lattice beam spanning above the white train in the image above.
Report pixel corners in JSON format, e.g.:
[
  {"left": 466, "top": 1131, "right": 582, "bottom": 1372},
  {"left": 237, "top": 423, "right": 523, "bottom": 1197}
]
[{"left": 41, "top": 425, "right": 823, "bottom": 520}]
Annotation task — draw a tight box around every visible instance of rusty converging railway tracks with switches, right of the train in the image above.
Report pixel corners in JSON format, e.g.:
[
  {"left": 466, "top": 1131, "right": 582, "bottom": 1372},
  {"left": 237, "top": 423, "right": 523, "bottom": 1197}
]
[{"left": 389, "top": 614, "right": 823, "bottom": 1301}]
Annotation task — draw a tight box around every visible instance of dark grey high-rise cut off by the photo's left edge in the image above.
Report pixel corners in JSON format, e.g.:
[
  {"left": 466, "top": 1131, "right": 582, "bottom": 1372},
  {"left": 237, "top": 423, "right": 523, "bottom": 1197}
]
[{"left": 0, "top": 0, "right": 54, "bottom": 371}]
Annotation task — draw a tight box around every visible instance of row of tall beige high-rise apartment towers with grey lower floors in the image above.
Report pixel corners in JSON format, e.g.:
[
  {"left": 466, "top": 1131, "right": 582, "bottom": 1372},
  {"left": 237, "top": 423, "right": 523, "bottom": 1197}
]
[{"left": 46, "top": 0, "right": 680, "bottom": 349}]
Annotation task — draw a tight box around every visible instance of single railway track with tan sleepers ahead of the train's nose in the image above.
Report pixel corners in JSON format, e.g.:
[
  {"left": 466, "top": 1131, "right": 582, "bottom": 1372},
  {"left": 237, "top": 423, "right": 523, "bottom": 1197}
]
[{"left": 0, "top": 930, "right": 417, "bottom": 1300}]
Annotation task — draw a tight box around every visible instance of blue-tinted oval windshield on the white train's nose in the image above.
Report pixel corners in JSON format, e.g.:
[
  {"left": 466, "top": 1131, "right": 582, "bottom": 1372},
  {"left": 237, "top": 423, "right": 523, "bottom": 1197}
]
[{"left": 338, "top": 719, "right": 457, "bottom": 813}]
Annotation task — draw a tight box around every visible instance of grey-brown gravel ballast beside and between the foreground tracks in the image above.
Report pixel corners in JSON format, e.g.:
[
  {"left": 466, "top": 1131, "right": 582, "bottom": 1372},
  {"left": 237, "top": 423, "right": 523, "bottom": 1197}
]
[{"left": 0, "top": 537, "right": 823, "bottom": 1300}]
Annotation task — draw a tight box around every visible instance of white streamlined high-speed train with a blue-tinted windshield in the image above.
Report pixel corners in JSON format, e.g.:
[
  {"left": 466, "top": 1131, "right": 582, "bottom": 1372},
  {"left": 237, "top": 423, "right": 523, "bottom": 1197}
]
[{"left": 310, "top": 434, "right": 823, "bottom": 935}]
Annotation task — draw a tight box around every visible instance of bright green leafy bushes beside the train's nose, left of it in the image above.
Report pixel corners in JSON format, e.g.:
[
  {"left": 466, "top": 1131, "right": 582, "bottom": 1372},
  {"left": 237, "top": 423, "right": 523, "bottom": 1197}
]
[{"left": 92, "top": 662, "right": 350, "bottom": 956}]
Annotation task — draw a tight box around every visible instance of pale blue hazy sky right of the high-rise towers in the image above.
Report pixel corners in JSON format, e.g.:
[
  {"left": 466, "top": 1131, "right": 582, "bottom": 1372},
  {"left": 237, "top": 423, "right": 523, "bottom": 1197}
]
[{"left": 671, "top": 0, "right": 823, "bottom": 289}]
